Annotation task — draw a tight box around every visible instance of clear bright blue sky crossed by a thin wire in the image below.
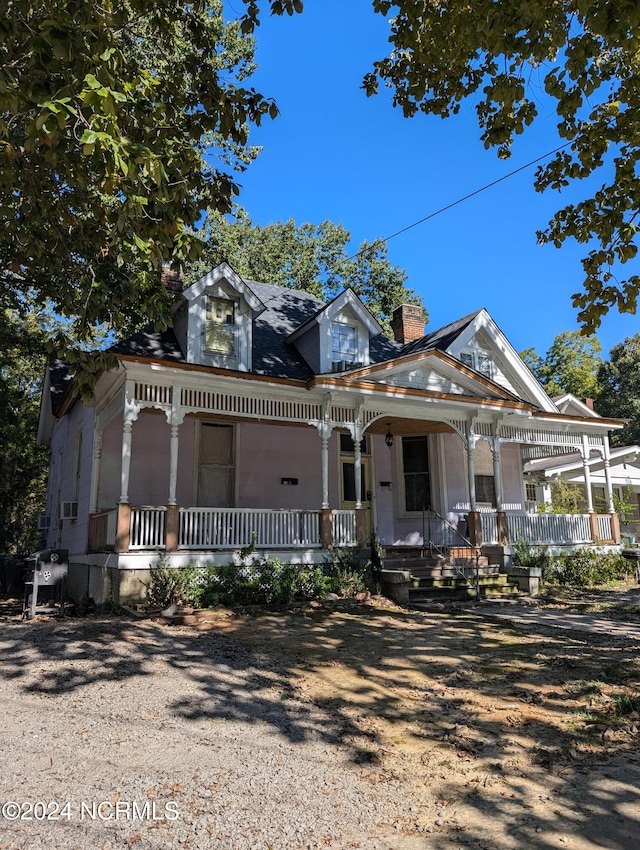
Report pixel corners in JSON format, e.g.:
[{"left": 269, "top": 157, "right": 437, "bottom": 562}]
[{"left": 228, "top": 0, "right": 640, "bottom": 355}]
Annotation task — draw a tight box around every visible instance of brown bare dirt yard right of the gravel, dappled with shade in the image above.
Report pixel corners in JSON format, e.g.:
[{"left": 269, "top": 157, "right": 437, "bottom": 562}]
[{"left": 0, "top": 586, "right": 640, "bottom": 850}]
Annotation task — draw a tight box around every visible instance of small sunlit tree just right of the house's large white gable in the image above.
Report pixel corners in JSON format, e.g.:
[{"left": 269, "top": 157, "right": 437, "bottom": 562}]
[{"left": 520, "top": 331, "right": 602, "bottom": 398}]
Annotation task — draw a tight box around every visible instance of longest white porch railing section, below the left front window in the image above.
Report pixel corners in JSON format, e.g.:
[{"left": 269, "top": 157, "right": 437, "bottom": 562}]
[{"left": 178, "top": 508, "right": 320, "bottom": 549}]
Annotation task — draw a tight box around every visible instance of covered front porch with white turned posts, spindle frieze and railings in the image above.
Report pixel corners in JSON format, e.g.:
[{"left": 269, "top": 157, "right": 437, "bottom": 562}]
[{"left": 87, "top": 364, "right": 620, "bottom": 556}]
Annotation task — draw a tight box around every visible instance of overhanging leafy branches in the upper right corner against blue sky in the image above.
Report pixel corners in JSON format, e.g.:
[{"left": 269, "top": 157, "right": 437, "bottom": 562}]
[{"left": 364, "top": 0, "right": 640, "bottom": 333}]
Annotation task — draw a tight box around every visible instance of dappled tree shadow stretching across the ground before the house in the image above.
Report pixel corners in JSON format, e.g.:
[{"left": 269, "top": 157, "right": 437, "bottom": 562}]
[{"left": 0, "top": 605, "right": 640, "bottom": 850}]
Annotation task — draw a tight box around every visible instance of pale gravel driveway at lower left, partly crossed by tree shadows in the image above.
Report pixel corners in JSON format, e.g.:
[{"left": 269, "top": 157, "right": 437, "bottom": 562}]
[{"left": 0, "top": 618, "right": 427, "bottom": 850}]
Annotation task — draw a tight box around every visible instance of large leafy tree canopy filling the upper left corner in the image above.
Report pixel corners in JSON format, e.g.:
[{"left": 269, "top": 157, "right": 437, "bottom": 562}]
[{"left": 0, "top": 0, "right": 301, "bottom": 390}]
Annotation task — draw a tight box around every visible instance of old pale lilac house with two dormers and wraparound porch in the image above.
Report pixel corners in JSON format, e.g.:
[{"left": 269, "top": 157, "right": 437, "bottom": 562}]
[{"left": 39, "top": 264, "right": 622, "bottom": 601}]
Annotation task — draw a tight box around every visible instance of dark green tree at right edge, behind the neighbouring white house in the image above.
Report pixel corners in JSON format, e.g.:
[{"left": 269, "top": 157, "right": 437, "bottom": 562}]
[{"left": 595, "top": 334, "right": 640, "bottom": 446}]
